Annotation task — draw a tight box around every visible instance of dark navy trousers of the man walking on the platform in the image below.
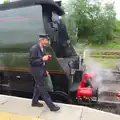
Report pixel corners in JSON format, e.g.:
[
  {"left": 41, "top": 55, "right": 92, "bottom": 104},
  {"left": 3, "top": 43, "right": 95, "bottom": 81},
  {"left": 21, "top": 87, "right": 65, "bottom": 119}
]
[{"left": 32, "top": 68, "right": 54, "bottom": 108}]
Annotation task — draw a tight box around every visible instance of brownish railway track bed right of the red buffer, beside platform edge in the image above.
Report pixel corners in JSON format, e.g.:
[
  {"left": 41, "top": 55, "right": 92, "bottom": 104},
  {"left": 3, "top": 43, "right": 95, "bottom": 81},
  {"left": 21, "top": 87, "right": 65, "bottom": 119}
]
[{"left": 93, "top": 71, "right": 120, "bottom": 115}]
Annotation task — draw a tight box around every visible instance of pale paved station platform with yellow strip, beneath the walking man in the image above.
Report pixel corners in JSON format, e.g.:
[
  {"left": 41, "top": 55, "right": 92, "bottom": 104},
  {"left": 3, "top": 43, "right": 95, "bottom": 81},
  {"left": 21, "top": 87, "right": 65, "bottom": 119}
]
[{"left": 0, "top": 95, "right": 120, "bottom": 120}]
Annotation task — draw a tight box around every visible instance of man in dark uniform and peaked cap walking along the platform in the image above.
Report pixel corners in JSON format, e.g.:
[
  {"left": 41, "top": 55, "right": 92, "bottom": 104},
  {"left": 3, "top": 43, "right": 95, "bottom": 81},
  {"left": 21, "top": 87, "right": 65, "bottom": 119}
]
[{"left": 29, "top": 34, "right": 60, "bottom": 111}]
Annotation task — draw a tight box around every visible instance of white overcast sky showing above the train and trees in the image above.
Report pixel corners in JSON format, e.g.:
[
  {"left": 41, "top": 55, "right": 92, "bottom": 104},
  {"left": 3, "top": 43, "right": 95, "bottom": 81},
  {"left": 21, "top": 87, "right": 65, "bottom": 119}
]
[{"left": 0, "top": 0, "right": 120, "bottom": 20}]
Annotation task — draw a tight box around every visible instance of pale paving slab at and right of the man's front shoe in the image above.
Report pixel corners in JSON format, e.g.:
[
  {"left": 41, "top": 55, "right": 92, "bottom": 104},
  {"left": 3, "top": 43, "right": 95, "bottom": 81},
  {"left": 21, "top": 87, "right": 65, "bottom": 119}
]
[{"left": 40, "top": 104, "right": 83, "bottom": 120}]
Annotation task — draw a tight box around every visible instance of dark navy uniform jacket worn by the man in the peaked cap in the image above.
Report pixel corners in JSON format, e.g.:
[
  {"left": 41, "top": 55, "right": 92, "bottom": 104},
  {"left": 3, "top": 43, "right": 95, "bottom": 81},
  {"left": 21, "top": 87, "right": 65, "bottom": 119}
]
[{"left": 29, "top": 44, "right": 46, "bottom": 76}]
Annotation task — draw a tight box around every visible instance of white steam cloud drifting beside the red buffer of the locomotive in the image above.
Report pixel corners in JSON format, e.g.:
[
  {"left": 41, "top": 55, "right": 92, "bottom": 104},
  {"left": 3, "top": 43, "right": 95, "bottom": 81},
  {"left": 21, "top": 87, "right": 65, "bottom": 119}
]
[{"left": 86, "top": 58, "right": 114, "bottom": 94}]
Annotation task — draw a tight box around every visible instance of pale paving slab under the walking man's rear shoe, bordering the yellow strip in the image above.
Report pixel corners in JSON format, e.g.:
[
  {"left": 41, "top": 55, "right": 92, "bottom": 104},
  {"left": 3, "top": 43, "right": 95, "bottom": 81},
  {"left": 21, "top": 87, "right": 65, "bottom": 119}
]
[{"left": 0, "top": 96, "right": 46, "bottom": 117}]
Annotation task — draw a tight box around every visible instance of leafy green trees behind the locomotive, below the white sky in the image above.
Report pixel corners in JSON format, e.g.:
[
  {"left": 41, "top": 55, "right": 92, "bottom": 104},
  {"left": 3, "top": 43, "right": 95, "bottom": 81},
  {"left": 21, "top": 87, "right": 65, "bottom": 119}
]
[{"left": 64, "top": 0, "right": 116, "bottom": 44}]
